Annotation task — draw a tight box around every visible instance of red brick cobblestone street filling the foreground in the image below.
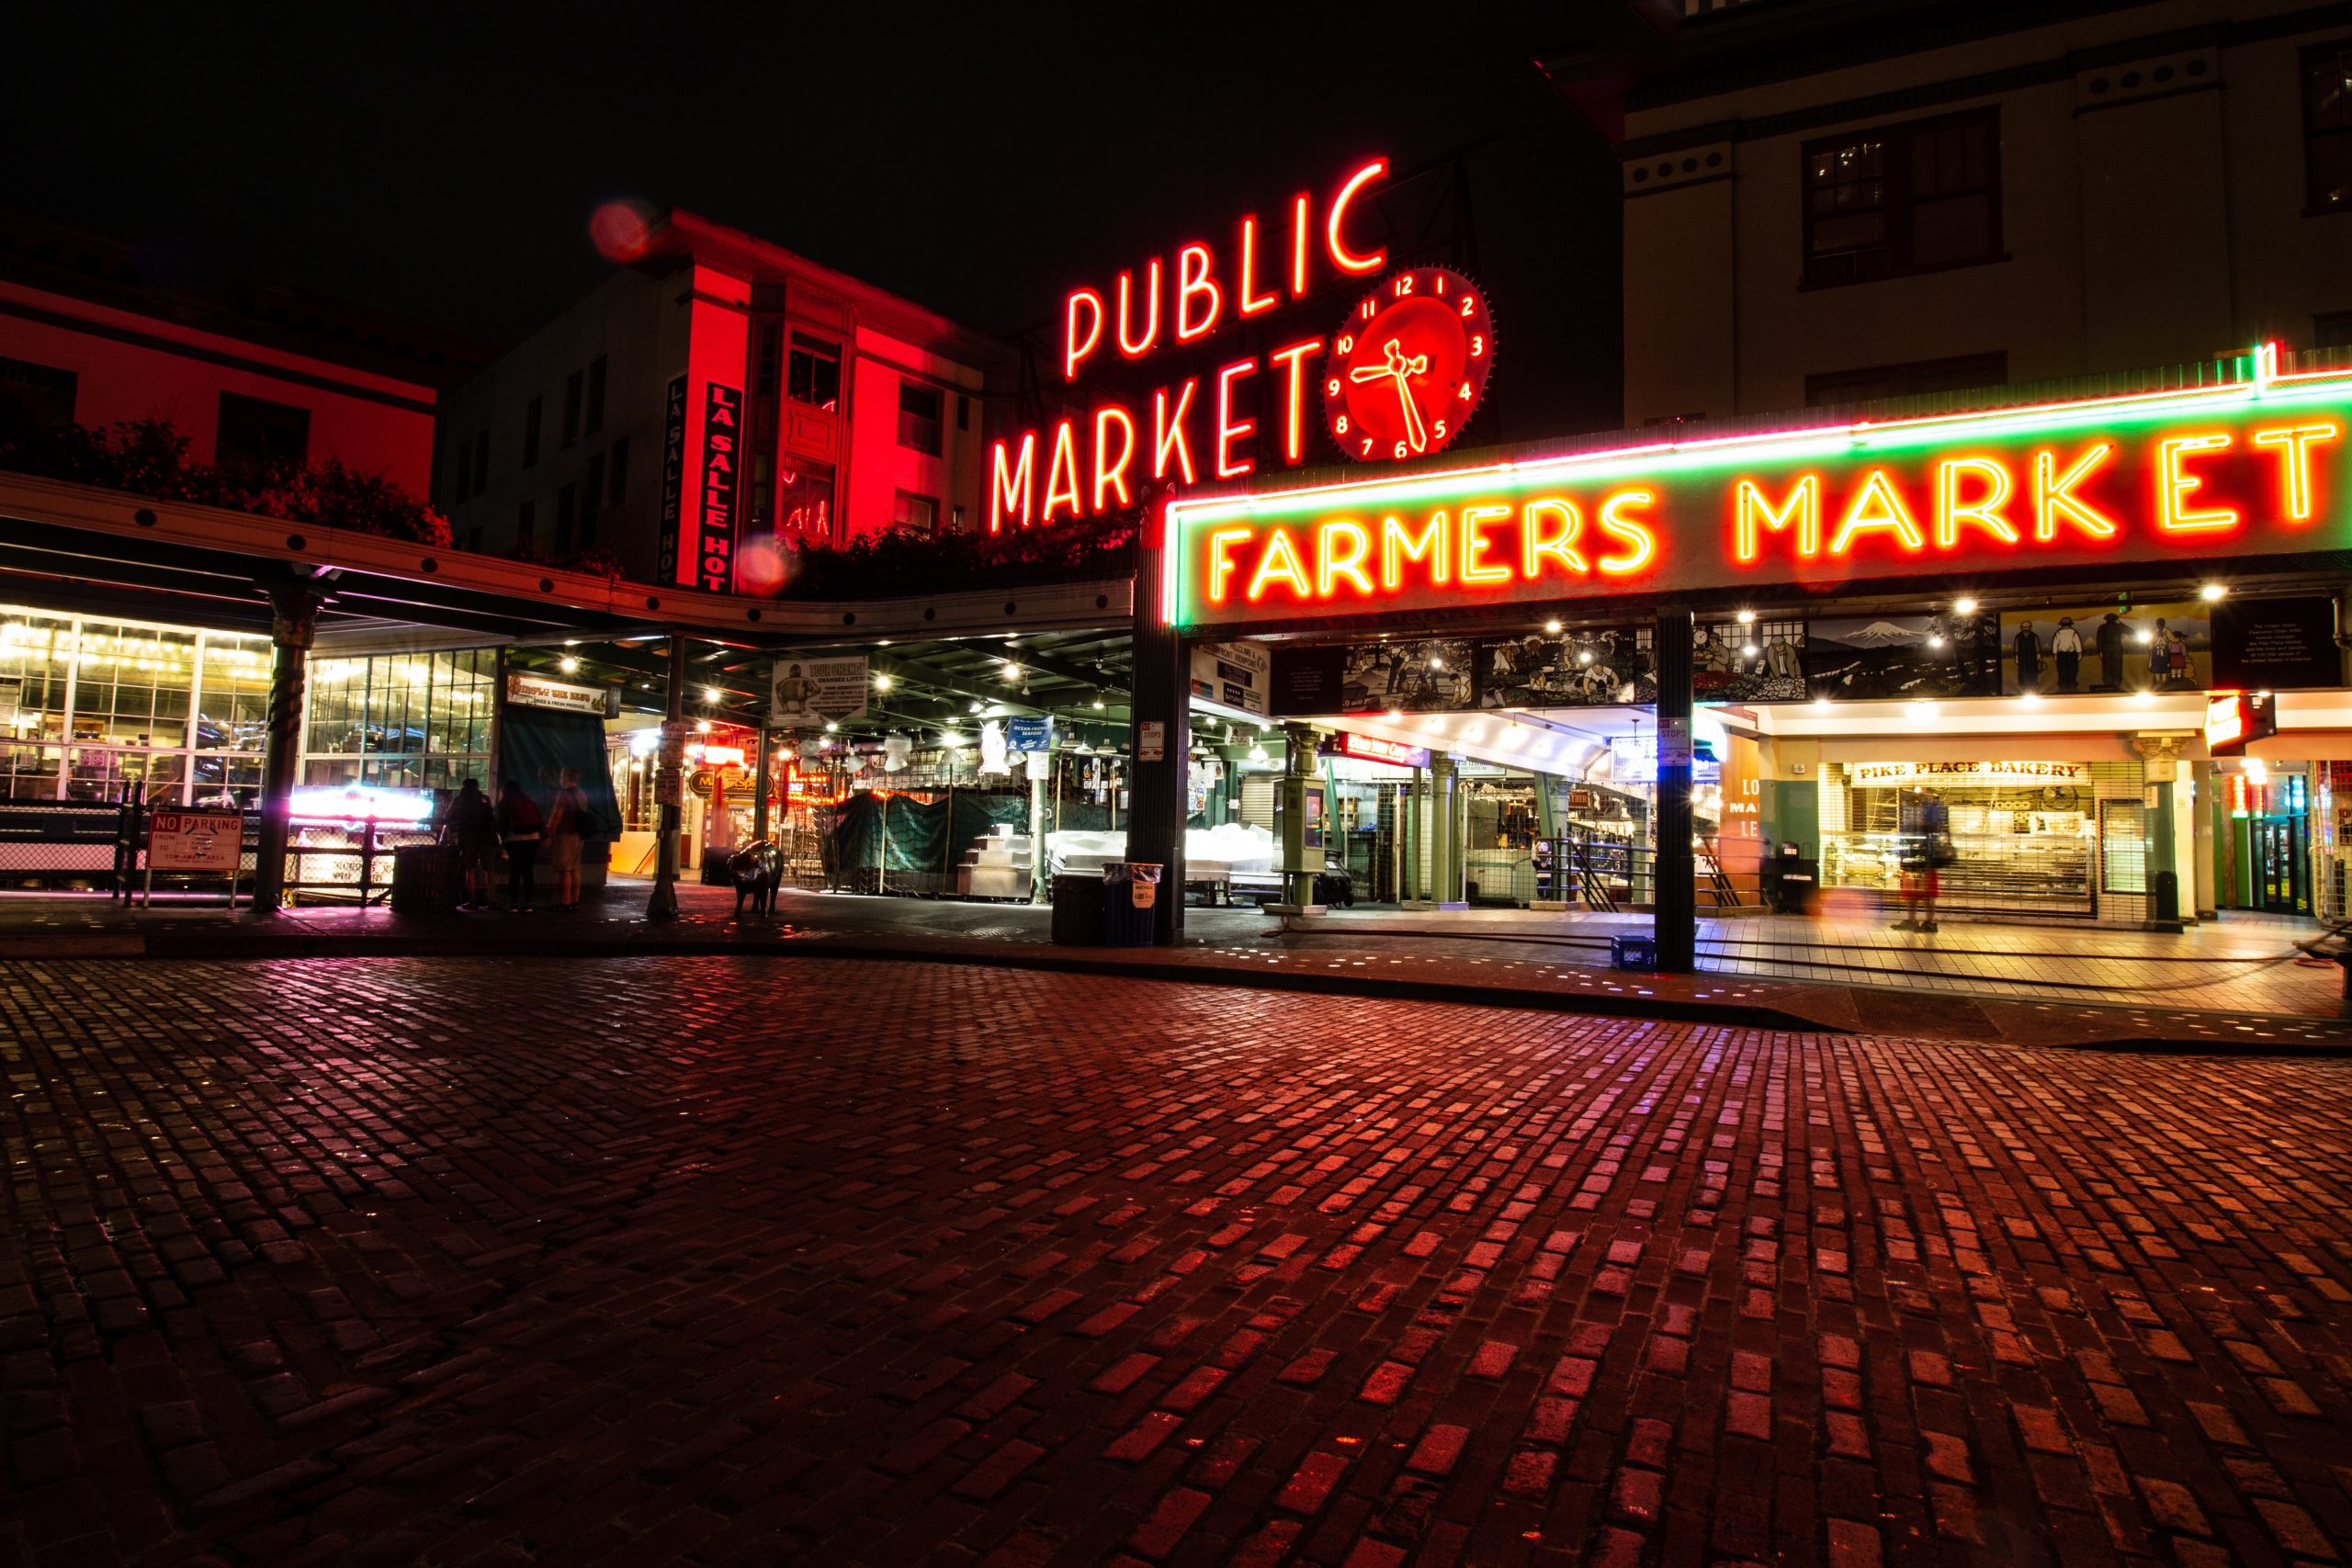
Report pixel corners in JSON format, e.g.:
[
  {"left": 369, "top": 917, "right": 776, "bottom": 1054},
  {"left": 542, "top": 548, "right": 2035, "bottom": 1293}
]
[{"left": 0, "top": 957, "right": 2352, "bottom": 1568}]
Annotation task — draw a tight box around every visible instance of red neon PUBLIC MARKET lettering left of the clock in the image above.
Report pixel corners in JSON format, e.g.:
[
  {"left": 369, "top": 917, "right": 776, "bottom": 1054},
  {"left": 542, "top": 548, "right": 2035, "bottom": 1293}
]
[{"left": 988, "top": 157, "right": 1387, "bottom": 534}]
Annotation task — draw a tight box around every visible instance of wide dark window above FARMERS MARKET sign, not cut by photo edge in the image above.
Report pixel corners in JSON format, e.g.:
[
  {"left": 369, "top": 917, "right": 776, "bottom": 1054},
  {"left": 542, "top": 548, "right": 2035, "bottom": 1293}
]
[{"left": 1804, "top": 110, "right": 2002, "bottom": 289}]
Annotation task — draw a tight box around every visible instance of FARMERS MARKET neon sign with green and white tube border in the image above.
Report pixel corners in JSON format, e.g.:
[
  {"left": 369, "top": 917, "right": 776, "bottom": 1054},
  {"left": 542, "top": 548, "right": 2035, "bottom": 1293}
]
[{"left": 1162, "top": 345, "right": 2352, "bottom": 627}]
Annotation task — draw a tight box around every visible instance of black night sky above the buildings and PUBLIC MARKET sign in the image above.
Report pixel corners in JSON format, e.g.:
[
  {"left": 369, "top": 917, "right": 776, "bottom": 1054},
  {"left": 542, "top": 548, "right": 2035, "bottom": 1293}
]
[{"left": 18, "top": 5, "right": 1618, "bottom": 442}]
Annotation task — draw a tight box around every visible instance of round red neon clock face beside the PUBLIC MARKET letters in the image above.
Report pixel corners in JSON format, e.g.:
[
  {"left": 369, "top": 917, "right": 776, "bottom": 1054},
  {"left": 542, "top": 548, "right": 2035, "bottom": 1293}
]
[{"left": 1324, "top": 265, "right": 1494, "bottom": 463}]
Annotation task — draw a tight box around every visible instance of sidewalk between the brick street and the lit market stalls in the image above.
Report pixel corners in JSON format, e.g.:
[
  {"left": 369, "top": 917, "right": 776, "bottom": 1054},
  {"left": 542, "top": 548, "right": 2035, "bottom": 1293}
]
[{"left": 0, "top": 882, "right": 2352, "bottom": 1054}]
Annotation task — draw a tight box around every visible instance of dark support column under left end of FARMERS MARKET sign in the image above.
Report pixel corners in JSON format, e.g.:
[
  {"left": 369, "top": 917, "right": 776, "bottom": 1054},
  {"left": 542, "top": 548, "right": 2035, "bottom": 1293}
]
[{"left": 1126, "top": 505, "right": 1193, "bottom": 947}]
